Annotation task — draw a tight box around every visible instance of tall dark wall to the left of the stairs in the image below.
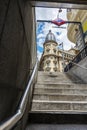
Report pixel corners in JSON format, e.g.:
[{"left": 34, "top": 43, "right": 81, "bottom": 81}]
[{"left": 0, "top": 0, "right": 36, "bottom": 127}]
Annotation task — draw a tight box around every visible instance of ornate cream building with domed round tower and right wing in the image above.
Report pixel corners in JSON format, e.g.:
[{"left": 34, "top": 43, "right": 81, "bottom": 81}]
[{"left": 40, "top": 30, "right": 75, "bottom": 72}]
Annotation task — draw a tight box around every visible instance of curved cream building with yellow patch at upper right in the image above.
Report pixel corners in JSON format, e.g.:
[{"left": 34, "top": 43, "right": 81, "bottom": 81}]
[{"left": 67, "top": 9, "right": 87, "bottom": 51}]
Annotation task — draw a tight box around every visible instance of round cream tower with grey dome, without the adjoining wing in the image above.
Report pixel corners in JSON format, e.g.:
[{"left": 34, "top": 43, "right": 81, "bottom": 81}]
[{"left": 41, "top": 30, "right": 58, "bottom": 72}]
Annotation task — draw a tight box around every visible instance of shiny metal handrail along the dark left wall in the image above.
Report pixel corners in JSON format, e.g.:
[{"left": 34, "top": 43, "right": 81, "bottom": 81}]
[{"left": 0, "top": 60, "right": 38, "bottom": 130}]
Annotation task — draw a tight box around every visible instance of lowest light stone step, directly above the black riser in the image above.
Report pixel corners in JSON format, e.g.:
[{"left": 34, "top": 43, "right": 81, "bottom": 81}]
[{"left": 31, "top": 100, "right": 87, "bottom": 112}]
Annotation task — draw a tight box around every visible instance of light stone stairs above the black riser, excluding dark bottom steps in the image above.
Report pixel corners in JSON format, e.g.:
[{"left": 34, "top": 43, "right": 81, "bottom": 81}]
[{"left": 30, "top": 71, "right": 87, "bottom": 113}]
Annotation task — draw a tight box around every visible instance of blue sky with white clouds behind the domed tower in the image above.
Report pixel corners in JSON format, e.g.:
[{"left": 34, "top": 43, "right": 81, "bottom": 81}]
[{"left": 35, "top": 7, "right": 75, "bottom": 59}]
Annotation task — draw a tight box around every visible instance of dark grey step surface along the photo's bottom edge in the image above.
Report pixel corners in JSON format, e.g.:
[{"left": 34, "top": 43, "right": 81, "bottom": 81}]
[{"left": 25, "top": 123, "right": 87, "bottom": 130}]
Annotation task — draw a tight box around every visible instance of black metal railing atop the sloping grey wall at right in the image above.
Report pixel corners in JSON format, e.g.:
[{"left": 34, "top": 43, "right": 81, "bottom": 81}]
[{"left": 64, "top": 46, "right": 87, "bottom": 72}]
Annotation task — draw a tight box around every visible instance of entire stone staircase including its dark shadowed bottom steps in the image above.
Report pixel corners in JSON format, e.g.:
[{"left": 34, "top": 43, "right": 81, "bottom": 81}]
[{"left": 26, "top": 71, "right": 87, "bottom": 130}]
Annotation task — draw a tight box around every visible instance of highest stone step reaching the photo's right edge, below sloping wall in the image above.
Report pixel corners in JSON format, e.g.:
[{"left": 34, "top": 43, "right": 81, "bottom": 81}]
[{"left": 35, "top": 83, "right": 87, "bottom": 89}]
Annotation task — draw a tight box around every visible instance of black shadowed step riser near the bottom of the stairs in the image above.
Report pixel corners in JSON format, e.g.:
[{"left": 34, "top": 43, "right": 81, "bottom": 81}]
[{"left": 28, "top": 110, "right": 87, "bottom": 124}]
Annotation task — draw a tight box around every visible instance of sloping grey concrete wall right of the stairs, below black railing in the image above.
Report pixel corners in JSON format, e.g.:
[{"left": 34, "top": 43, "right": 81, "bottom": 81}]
[{"left": 68, "top": 57, "right": 87, "bottom": 83}]
